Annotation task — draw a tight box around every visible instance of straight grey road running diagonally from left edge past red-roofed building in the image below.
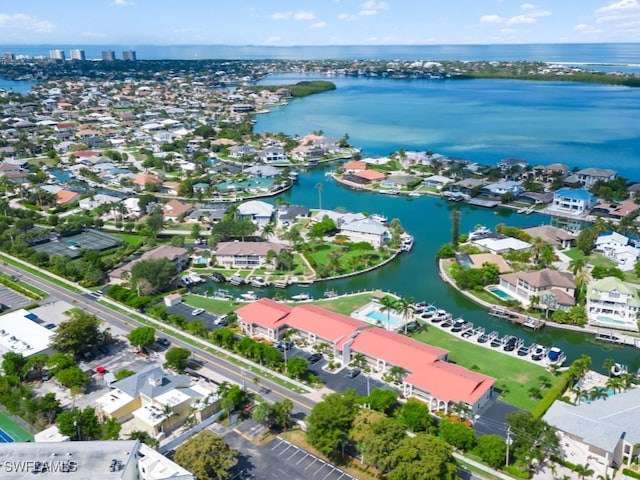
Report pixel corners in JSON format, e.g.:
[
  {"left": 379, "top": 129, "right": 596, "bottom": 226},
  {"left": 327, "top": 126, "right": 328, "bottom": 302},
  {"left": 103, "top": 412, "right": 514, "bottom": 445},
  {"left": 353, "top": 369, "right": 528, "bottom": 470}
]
[{"left": 0, "top": 264, "right": 316, "bottom": 417}]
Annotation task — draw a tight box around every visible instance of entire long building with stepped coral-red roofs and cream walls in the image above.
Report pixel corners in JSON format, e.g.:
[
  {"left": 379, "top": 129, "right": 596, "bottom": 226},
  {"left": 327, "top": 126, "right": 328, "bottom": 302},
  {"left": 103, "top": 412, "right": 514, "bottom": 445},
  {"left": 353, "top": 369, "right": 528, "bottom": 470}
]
[{"left": 236, "top": 298, "right": 495, "bottom": 414}]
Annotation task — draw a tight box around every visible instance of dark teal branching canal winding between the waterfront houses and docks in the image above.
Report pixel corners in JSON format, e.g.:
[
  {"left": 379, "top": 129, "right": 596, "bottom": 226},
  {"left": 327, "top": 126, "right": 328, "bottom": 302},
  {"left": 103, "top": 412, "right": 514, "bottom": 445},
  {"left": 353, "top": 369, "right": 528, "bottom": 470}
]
[{"left": 195, "top": 165, "right": 640, "bottom": 371}]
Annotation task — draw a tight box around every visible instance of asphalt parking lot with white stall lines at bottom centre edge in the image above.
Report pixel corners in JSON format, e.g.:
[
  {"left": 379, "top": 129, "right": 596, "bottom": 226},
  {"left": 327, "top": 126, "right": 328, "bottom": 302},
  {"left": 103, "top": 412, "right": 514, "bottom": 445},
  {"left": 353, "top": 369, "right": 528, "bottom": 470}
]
[{"left": 224, "top": 432, "right": 357, "bottom": 480}]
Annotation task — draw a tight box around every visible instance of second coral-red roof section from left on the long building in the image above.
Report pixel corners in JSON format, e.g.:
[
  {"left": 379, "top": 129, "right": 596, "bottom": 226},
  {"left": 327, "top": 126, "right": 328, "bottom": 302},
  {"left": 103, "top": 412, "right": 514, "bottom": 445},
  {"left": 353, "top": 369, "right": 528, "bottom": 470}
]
[{"left": 286, "top": 305, "right": 369, "bottom": 348}]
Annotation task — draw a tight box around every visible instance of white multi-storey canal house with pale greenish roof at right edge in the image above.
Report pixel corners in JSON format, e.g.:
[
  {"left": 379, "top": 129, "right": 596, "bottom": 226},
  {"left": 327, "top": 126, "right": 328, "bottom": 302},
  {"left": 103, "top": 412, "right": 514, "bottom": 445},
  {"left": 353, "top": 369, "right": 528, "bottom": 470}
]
[{"left": 585, "top": 277, "right": 640, "bottom": 332}]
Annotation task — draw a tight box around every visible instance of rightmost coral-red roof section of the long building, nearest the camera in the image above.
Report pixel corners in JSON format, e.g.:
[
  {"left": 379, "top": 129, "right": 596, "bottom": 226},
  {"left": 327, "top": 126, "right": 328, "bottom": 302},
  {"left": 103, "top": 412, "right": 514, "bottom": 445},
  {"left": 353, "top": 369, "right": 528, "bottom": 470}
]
[{"left": 405, "top": 361, "right": 495, "bottom": 405}]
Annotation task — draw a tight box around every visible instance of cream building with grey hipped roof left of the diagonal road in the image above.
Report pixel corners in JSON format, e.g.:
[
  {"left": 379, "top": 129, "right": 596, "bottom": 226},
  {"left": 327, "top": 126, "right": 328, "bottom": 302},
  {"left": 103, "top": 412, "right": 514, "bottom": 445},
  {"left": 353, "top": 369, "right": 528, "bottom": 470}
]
[{"left": 96, "top": 367, "right": 219, "bottom": 437}]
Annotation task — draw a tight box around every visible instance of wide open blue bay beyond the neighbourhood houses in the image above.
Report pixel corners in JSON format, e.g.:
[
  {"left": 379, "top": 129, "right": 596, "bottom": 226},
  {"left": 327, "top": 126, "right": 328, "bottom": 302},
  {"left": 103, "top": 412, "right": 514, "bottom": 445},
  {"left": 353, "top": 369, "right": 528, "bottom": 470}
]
[{"left": 255, "top": 74, "right": 640, "bottom": 181}]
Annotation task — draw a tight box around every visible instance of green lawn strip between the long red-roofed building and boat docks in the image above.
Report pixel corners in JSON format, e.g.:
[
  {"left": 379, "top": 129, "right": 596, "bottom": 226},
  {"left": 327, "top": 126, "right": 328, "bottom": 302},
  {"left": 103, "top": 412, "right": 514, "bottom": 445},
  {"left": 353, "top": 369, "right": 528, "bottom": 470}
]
[{"left": 413, "top": 326, "right": 555, "bottom": 410}]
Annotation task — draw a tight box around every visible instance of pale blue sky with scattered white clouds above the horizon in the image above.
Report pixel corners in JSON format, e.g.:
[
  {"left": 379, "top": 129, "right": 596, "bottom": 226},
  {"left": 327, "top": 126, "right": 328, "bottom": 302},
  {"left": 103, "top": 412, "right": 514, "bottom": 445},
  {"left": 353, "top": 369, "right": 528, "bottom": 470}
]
[{"left": 0, "top": 0, "right": 640, "bottom": 46}]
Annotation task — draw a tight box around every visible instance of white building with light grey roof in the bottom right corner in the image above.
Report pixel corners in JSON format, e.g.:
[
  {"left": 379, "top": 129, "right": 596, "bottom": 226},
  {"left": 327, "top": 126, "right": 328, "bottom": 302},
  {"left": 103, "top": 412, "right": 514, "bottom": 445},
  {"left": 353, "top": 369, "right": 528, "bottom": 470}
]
[{"left": 543, "top": 388, "right": 640, "bottom": 471}]
